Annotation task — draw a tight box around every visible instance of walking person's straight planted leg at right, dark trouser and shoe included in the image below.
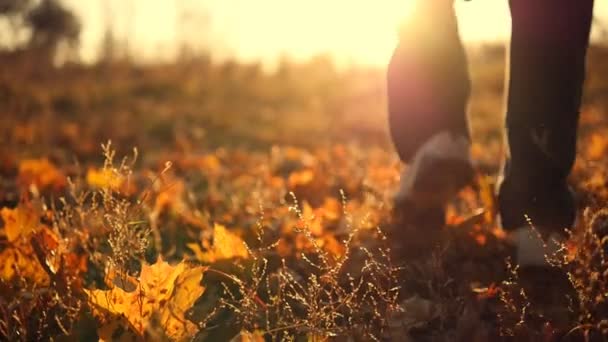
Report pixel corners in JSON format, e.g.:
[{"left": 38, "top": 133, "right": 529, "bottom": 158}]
[{"left": 498, "top": 0, "right": 593, "bottom": 320}]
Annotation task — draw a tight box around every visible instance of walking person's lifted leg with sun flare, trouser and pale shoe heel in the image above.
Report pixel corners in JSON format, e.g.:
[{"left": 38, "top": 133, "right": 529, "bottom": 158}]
[{"left": 387, "top": 0, "right": 473, "bottom": 217}]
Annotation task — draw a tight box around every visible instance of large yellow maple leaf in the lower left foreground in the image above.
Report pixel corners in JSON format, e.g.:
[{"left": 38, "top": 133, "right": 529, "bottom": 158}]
[{"left": 85, "top": 258, "right": 206, "bottom": 341}]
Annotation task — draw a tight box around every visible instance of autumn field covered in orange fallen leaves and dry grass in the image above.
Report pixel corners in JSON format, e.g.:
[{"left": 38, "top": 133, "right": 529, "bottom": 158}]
[{"left": 0, "top": 46, "right": 608, "bottom": 341}]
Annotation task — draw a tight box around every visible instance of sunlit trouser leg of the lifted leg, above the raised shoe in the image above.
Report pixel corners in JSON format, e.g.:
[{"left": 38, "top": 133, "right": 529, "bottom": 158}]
[{"left": 387, "top": 6, "right": 470, "bottom": 163}]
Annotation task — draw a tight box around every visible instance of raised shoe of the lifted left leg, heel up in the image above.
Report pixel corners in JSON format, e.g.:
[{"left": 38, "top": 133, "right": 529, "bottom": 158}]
[{"left": 389, "top": 131, "right": 474, "bottom": 260}]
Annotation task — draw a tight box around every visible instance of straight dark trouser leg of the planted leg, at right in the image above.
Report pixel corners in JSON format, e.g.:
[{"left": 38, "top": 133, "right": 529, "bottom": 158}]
[{"left": 499, "top": 0, "right": 593, "bottom": 229}]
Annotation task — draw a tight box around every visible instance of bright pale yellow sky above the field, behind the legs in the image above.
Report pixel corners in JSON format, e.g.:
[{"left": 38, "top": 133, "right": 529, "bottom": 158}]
[{"left": 64, "top": 0, "right": 608, "bottom": 65}]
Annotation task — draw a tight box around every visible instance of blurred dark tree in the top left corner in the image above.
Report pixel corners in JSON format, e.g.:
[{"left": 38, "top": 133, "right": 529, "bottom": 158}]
[{"left": 0, "top": 0, "right": 81, "bottom": 64}]
